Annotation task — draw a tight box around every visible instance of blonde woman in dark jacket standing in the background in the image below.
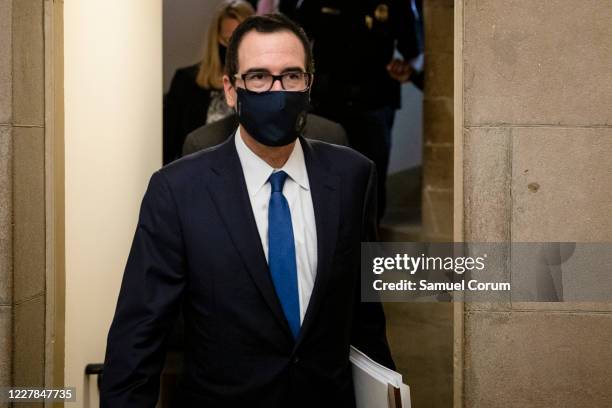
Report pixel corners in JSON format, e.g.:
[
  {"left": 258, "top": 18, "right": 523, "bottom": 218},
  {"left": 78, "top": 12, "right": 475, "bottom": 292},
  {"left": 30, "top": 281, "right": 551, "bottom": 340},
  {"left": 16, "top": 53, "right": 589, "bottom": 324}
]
[{"left": 163, "top": 0, "right": 255, "bottom": 165}]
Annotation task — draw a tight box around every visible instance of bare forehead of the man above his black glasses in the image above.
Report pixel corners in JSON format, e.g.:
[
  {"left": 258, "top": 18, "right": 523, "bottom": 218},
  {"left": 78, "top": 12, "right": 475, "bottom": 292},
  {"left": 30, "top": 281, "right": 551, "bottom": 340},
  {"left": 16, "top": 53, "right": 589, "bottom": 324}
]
[{"left": 238, "top": 30, "right": 306, "bottom": 72}]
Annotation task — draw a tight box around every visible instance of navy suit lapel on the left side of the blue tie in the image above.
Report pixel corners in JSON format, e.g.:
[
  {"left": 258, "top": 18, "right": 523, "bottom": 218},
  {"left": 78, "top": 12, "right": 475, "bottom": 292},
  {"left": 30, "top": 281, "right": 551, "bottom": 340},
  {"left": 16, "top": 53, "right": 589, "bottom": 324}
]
[{"left": 208, "top": 137, "right": 293, "bottom": 338}]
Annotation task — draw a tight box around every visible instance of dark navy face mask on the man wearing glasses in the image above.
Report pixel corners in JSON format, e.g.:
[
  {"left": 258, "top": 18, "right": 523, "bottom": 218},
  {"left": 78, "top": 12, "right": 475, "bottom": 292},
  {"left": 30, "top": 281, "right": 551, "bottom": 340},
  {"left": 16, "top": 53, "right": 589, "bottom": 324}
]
[{"left": 236, "top": 88, "right": 310, "bottom": 146}]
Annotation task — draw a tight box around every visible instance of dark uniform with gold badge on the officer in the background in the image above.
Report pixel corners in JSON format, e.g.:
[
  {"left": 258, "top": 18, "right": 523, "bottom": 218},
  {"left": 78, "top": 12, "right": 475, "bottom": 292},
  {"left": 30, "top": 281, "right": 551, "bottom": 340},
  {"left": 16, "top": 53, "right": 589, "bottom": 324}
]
[{"left": 280, "top": 0, "right": 420, "bottom": 220}]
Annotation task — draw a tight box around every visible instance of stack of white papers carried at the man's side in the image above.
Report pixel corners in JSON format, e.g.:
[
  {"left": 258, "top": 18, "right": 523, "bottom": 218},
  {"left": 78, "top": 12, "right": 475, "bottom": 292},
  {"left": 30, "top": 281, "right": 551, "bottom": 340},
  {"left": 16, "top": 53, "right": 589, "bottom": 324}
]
[{"left": 349, "top": 346, "right": 410, "bottom": 408}]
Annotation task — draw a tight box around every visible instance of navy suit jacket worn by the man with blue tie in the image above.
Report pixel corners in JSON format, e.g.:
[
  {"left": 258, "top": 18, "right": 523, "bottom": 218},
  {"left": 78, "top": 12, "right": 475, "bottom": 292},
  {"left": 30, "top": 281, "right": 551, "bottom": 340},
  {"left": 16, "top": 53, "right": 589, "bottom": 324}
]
[{"left": 101, "top": 137, "right": 394, "bottom": 408}]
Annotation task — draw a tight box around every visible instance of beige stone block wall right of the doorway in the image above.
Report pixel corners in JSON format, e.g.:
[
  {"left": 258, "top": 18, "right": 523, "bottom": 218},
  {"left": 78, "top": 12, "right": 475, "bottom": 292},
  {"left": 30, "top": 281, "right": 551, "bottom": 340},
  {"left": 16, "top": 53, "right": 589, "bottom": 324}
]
[{"left": 455, "top": 0, "right": 612, "bottom": 408}]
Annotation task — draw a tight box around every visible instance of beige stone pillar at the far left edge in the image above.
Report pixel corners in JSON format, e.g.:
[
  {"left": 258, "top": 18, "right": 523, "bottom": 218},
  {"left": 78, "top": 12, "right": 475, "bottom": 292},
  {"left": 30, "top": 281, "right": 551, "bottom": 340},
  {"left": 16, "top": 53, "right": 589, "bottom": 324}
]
[{"left": 0, "top": 0, "right": 45, "bottom": 402}]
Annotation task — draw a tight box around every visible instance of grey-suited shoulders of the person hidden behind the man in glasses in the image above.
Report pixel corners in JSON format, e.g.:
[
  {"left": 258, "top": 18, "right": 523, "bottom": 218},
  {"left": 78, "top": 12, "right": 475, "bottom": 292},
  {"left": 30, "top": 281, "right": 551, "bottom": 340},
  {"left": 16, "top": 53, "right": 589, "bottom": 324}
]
[{"left": 183, "top": 114, "right": 348, "bottom": 156}]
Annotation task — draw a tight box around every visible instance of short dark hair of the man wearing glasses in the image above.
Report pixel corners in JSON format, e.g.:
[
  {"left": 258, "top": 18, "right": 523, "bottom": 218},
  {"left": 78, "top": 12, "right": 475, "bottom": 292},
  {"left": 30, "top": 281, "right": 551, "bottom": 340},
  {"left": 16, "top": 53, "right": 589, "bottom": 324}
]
[{"left": 225, "top": 14, "right": 314, "bottom": 84}]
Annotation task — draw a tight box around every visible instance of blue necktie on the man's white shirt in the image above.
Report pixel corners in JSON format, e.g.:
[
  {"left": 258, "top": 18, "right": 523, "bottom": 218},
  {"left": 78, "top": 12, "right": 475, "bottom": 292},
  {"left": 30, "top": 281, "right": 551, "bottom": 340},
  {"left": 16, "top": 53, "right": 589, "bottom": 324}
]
[{"left": 268, "top": 171, "right": 300, "bottom": 338}]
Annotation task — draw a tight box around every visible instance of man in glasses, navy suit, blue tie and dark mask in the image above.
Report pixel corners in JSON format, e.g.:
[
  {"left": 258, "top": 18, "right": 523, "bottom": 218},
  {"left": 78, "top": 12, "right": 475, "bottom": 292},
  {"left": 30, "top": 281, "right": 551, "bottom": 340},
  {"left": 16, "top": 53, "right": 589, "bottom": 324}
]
[{"left": 101, "top": 15, "right": 394, "bottom": 408}]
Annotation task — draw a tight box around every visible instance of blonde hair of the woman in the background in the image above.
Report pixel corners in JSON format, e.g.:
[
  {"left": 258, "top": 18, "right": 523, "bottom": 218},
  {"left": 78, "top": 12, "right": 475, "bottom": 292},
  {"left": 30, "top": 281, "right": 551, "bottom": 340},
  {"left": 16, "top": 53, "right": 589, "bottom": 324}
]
[{"left": 196, "top": 0, "right": 255, "bottom": 89}]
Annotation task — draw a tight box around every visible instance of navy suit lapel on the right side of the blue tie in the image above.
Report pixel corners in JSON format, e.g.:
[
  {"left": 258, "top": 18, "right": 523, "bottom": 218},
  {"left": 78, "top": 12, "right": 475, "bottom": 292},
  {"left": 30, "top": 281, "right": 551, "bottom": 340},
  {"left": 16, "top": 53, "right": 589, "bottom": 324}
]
[{"left": 295, "top": 138, "right": 340, "bottom": 348}]
